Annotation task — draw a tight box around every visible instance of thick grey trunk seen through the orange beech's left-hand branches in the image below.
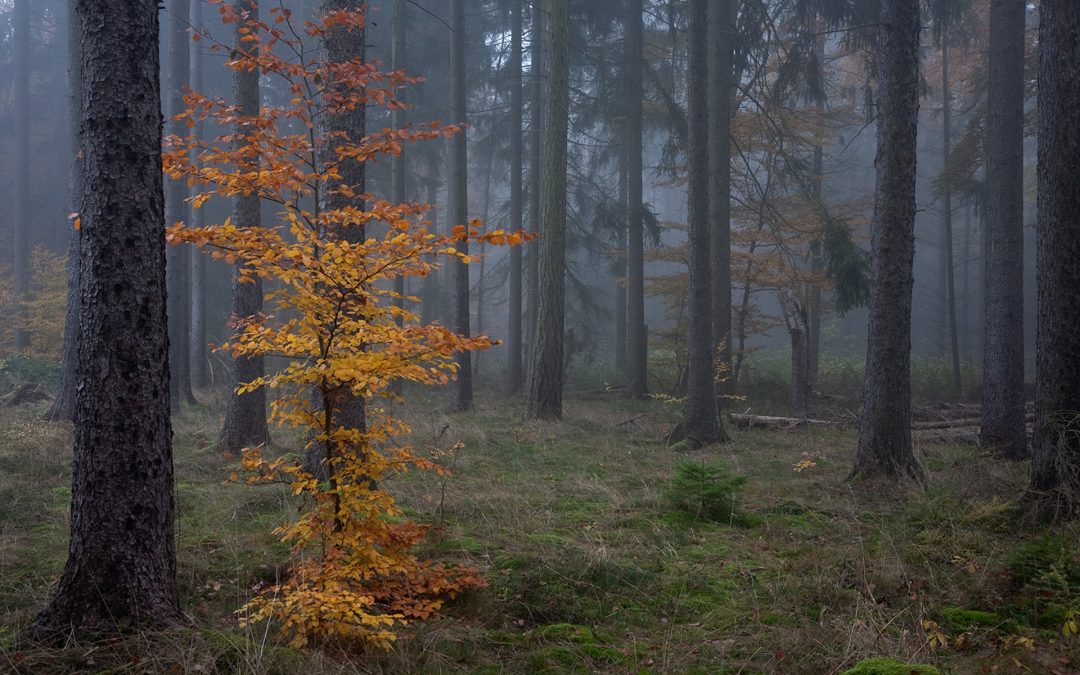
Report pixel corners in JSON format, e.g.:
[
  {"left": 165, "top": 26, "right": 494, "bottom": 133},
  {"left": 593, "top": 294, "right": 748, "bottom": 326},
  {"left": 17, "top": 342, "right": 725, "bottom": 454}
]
[{"left": 218, "top": 0, "right": 270, "bottom": 454}]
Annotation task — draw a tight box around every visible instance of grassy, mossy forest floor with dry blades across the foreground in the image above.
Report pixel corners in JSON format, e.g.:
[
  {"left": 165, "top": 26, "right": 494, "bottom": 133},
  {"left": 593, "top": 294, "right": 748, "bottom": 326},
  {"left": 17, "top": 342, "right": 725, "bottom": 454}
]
[{"left": 0, "top": 386, "right": 1080, "bottom": 674}]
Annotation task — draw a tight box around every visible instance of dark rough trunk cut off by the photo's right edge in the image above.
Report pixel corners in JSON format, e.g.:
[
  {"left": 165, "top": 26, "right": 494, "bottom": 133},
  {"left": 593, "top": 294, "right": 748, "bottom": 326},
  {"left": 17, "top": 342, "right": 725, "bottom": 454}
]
[{"left": 1028, "top": 0, "right": 1080, "bottom": 518}]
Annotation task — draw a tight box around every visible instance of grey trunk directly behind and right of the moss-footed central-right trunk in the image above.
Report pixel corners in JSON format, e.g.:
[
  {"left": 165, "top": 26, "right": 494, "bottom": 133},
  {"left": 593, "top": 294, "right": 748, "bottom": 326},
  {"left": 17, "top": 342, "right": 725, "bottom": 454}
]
[{"left": 708, "top": 0, "right": 734, "bottom": 399}]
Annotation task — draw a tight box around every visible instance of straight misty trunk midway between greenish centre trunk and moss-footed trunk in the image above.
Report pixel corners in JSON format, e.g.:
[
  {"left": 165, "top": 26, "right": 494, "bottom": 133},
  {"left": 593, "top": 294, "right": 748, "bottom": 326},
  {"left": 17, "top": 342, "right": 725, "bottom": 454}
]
[{"left": 626, "top": 0, "right": 649, "bottom": 399}]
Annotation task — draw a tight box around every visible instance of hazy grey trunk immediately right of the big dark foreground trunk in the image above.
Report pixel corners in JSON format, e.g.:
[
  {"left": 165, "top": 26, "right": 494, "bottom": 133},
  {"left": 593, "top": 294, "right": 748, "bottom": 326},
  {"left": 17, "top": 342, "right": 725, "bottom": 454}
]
[{"left": 165, "top": 0, "right": 197, "bottom": 409}]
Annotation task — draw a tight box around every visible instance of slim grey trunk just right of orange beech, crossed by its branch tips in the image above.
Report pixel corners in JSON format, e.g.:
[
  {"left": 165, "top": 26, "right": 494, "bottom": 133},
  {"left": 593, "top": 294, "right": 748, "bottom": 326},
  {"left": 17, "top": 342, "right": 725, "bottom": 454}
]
[{"left": 447, "top": 0, "right": 473, "bottom": 413}]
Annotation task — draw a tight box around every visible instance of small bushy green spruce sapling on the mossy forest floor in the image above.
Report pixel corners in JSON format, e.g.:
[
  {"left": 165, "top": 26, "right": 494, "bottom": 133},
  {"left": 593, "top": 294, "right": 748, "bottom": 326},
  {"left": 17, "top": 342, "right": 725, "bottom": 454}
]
[{"left": 664, "top": 460, "right": 746, "bottom": 523}]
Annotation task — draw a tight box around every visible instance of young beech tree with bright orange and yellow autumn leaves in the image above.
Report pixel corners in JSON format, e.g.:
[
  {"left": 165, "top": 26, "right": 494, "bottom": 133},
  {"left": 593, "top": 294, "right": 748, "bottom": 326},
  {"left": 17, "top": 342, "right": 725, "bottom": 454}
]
[{"left": 165, "top": 5, "right": 522, "bottom": 647}]
